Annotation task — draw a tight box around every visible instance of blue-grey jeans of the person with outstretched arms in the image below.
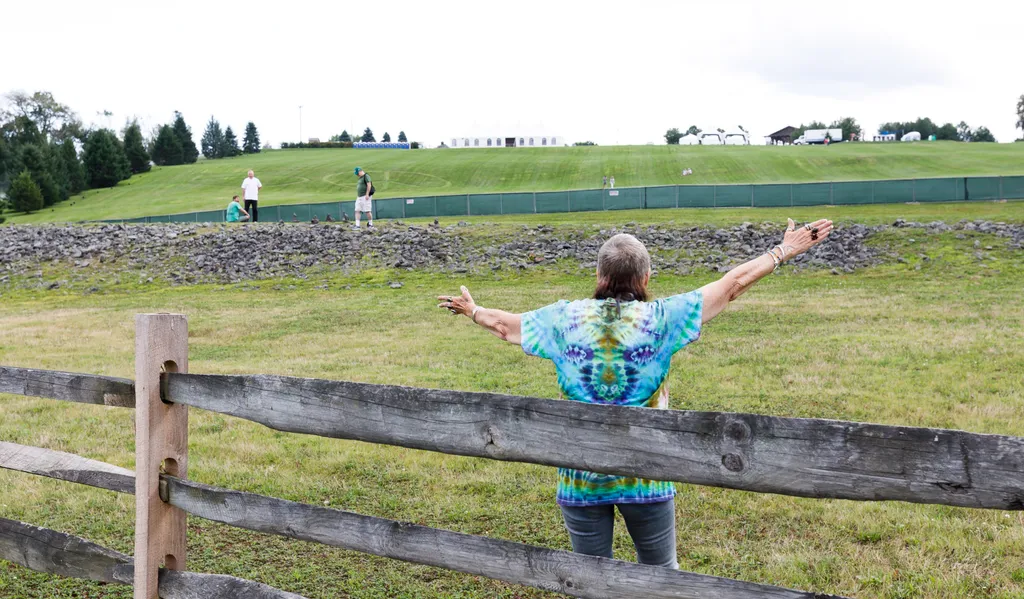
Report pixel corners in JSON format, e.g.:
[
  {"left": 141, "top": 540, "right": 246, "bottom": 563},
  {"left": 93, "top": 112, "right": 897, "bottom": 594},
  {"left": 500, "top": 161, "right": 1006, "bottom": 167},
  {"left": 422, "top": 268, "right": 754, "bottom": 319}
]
[{"left": 560, "top": 500, "right": 679, "bottom": 569}]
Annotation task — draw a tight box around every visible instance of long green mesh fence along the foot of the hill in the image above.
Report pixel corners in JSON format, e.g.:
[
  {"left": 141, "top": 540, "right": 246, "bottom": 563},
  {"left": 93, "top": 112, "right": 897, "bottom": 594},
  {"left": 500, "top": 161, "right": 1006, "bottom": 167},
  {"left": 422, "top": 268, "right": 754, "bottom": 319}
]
[{"left": 92, "top": 176, "right": 1024, "bottom": 223}]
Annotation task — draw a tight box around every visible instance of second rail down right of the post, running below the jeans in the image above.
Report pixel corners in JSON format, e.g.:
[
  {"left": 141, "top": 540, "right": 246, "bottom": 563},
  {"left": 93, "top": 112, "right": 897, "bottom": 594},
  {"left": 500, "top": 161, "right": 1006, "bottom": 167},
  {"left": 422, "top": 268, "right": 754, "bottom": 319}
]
[{"left": 161, "top": 476, "right": 831, "bottom": 599}]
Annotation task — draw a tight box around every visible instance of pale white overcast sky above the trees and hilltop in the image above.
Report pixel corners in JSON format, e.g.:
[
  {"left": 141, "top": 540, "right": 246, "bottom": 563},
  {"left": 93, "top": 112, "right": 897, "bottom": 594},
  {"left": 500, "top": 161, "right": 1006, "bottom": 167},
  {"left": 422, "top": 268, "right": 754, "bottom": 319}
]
[{"left": 0, "top": 0, "right": 1024, "bottom": 146}]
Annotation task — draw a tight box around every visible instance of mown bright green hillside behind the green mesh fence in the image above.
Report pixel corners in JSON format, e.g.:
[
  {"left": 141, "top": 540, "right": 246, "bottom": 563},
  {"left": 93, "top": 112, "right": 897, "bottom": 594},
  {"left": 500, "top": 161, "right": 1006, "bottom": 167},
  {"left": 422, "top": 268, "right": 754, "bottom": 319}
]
[{"left": 8, "top": 142, "right": 1024, "bottom": 222}]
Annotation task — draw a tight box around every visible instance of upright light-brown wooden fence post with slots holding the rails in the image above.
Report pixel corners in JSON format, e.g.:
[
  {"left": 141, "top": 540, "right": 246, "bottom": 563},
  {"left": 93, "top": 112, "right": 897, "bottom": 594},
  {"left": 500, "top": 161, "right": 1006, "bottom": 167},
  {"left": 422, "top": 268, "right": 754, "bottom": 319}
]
[{"left": 134, "top": 314, "right": 188, "bottom": 599}]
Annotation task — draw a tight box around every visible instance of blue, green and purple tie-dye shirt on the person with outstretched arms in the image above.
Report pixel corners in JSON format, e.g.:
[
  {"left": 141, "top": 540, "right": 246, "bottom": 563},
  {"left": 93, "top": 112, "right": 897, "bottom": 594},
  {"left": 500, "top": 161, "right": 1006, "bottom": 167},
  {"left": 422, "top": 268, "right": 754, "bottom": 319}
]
[{"left": 522, "top": 290, "right": 703, "bottom": 506}]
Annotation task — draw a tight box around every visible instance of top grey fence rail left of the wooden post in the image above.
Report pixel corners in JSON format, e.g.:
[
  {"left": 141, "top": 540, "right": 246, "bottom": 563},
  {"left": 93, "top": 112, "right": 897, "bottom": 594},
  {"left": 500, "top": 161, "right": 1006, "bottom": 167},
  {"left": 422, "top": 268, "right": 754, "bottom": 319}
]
[{"left": 0, "top": 366, "right": 135, "bottom": 408}]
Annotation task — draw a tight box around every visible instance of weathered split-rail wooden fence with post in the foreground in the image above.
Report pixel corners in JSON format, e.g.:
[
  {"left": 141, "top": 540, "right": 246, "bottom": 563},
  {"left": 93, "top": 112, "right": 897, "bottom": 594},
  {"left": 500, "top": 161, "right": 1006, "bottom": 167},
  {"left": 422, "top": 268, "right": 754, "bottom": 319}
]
[{"left": 0, "top": 314, "right": 1024, "bottom": 599}]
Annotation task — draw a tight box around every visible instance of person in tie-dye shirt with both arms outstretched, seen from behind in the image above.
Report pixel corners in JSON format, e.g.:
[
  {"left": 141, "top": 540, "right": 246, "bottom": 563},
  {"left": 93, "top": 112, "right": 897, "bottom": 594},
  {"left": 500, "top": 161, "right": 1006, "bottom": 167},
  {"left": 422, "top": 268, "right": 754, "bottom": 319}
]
[{"left": 437, "top": 219, "right": 833, "bottom": 568}]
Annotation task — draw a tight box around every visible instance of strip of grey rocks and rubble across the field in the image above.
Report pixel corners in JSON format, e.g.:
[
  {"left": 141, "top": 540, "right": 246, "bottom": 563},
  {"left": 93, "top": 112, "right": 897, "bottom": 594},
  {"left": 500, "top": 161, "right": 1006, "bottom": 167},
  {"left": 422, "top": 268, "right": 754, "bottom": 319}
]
[{"left": 0, "top": 220, "right": 1024, "bottom": 289}]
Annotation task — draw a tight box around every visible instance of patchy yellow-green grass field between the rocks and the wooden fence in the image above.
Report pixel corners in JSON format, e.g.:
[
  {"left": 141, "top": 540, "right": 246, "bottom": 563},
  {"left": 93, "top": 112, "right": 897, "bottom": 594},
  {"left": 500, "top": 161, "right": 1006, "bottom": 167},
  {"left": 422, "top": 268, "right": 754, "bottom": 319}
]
[{"left": 0, "top": 202, "right": 1024, "bottom": 599}]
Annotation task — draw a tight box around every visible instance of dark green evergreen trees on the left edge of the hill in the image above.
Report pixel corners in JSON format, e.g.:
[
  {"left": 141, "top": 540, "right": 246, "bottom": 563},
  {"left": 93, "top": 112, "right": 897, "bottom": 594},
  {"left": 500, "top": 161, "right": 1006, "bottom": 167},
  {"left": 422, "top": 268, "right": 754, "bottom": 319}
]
[{"left": 0, "top": 91, "right": 260, "bottom": 216}]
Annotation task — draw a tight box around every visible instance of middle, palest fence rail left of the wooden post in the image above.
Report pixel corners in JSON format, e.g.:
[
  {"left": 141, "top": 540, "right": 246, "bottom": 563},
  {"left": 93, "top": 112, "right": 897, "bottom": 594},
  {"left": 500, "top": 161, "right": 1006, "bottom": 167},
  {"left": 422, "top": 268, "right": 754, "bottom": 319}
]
[{"left": 0, "top": 441, "right": 135, "bottom": 495}]
